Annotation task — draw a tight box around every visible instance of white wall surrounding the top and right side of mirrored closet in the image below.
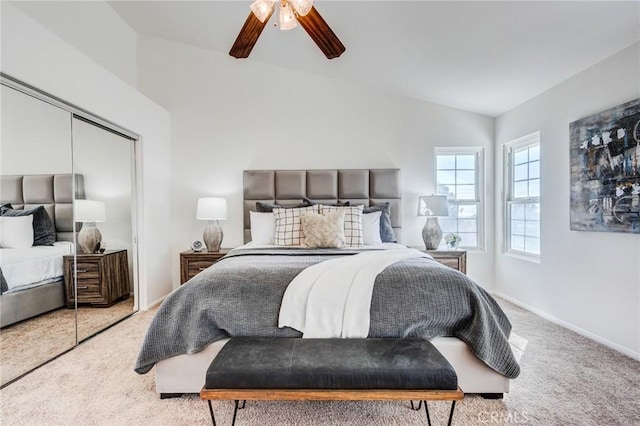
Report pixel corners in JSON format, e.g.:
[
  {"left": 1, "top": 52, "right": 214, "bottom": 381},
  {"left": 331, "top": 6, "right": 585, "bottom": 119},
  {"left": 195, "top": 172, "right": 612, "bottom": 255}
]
[{"left": 0, "top": 2, "right": 174, "bottom": 309}]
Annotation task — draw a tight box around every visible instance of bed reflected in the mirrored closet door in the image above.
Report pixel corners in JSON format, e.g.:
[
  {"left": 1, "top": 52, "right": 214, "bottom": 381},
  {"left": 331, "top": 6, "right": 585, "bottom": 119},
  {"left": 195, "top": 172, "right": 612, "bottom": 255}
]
[{"left": 0, "top": 174, "right": 84, "bottom": 327}]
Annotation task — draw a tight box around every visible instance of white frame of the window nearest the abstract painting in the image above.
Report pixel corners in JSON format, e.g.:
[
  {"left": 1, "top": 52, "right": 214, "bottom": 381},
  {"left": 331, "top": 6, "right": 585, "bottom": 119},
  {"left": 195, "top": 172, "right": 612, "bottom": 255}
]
[{"left": 503, "top": 131, "right": 542, "bottom": 263}]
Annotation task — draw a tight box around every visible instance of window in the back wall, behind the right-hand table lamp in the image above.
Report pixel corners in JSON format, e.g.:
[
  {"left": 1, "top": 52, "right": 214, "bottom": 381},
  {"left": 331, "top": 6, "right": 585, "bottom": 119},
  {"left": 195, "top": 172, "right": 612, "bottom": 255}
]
[{"left": 435, "top": 148, "right": 484, "bottom": 250}]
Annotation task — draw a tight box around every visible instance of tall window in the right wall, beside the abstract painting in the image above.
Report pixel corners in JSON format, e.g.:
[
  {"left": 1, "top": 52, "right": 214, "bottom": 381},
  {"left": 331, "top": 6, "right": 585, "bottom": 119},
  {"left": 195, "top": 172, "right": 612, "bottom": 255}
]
[{"left": 505, "top": 132, "right": 540, "bottom": 258}]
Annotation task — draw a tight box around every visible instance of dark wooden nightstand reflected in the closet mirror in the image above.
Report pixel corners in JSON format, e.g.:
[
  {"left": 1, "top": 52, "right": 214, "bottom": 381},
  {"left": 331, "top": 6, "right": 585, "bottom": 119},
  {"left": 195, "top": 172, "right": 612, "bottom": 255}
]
[{"left": 63, "top": 250, "right": 131, "bottom": 308}]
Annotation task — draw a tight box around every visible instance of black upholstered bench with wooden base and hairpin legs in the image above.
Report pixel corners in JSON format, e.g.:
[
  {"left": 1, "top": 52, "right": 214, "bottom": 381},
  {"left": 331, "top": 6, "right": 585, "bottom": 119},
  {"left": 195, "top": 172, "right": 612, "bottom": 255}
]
[{"left": 200, "top": 338, "right": 464, "bottom": 426}]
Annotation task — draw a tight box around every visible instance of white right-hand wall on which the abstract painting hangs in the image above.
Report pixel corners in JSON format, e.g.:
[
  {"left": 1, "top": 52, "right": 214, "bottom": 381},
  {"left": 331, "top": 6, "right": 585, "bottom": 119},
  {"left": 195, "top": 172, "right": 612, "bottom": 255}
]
[{"left": 495, "top": 43, "right": 640, "bottom": 359}]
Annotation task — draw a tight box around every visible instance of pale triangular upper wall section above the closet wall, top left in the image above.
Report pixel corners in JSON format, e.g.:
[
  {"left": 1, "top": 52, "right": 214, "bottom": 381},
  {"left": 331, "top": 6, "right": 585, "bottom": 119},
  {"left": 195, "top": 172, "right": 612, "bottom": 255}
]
[{"left": 7, "top": 0, "right": 138, "bottom": 87}]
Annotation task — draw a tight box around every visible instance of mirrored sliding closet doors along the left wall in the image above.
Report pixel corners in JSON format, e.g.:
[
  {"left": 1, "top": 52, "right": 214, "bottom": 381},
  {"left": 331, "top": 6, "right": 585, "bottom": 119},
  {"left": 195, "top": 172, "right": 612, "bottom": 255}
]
[{"left": 0, "top": 74, "right": 137, "bottom": 386}]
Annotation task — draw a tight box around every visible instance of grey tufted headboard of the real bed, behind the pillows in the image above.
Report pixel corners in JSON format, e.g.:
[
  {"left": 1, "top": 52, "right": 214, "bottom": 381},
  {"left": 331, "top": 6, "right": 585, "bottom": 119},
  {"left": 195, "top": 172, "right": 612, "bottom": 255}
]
[{"left": 243, "top": 169, "right": 402, "bottom": 242}]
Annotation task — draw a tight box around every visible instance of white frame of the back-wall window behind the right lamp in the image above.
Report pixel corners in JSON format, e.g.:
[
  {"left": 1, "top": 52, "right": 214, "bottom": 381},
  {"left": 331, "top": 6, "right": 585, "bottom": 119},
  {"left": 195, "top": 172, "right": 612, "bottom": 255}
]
[{"left": 434, "top": 146, "right": 486, "bottom": 253}]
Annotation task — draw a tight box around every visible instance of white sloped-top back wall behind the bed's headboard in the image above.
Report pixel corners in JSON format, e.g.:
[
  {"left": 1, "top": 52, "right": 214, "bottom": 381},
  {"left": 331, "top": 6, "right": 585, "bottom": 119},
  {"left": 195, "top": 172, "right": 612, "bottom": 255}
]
[{"left": 138, "top": 36, "right": 493, "bottom": 288}]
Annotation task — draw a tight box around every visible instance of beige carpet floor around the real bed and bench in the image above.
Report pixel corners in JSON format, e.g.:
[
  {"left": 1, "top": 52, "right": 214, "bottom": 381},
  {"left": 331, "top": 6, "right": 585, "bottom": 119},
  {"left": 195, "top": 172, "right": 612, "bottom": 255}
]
[{"left": 0, "top": 301, "right": 640, "bottom": 426}]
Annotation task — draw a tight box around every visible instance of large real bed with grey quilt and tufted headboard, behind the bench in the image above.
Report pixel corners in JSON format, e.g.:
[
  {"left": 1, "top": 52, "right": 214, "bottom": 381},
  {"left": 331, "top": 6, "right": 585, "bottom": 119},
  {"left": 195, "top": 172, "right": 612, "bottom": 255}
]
[{"left": 135, "top": 169, "right": 519, "bottom": 396}]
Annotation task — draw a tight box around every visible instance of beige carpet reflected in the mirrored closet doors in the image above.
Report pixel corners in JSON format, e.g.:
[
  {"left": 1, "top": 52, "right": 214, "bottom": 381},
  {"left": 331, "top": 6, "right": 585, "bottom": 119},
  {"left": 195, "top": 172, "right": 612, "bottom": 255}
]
[{"left": 0, "top": 297, "right": 133, "bottom": 384}]
